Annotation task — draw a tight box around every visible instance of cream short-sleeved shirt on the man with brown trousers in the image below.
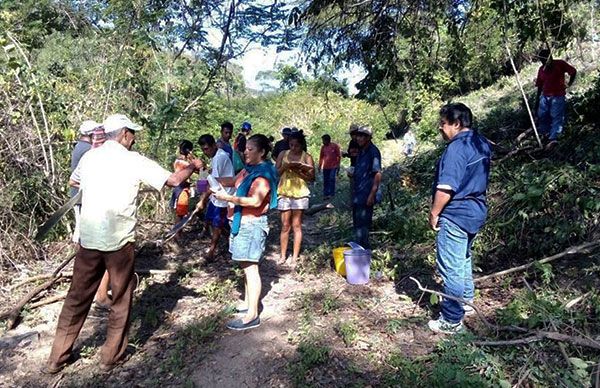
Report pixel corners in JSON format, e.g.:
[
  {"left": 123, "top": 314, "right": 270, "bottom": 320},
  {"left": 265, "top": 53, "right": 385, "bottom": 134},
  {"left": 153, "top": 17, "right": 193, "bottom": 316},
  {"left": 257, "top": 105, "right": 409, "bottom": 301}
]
[{"left": 71, "top": 140, "right": 171, "bottom": 252}]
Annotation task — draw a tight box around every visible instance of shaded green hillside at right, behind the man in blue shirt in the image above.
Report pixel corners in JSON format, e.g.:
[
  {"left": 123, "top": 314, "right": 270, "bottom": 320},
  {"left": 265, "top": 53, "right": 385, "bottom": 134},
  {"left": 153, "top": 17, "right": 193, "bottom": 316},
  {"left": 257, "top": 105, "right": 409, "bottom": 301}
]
[{"left": 305, "top": 47, "right": 600, "bottom": 386}]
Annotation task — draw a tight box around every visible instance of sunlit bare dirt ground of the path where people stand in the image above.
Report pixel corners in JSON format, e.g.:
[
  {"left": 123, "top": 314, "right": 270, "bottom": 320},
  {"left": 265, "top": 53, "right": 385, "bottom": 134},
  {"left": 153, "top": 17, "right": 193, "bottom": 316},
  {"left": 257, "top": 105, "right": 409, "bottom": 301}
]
[{"left": 0, "top": 206, "right": 506, "bottom": 387}]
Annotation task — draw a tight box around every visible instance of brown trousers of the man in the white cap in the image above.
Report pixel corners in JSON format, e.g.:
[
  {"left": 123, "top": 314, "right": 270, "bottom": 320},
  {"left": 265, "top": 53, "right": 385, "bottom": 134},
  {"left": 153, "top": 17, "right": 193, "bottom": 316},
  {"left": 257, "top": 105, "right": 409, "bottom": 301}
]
[{"left": 48, "top": 243, "right": 135, "bottom": 364}]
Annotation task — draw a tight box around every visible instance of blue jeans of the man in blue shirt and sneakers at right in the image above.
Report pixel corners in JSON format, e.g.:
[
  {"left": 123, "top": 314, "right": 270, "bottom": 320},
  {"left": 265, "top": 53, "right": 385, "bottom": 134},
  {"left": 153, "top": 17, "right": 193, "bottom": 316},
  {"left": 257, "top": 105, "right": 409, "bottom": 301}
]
[{"left": 436, "top": 218, "right": 475, "bottom": 323}]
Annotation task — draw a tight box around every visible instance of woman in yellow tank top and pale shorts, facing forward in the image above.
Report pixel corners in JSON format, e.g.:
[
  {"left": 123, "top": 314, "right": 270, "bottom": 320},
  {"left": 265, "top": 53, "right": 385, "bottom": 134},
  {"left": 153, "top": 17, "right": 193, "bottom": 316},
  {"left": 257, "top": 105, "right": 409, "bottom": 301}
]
[{"left": 276, "top": 131, "right": 315, "bottom": 265}]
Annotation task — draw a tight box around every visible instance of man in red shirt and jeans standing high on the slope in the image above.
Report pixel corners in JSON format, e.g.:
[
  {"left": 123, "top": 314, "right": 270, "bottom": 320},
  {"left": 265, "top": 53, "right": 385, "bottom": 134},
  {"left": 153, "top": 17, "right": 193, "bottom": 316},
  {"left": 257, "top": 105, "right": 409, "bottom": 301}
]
[{"left": 535, "top": 49, "right": 577, "bottom": 148}]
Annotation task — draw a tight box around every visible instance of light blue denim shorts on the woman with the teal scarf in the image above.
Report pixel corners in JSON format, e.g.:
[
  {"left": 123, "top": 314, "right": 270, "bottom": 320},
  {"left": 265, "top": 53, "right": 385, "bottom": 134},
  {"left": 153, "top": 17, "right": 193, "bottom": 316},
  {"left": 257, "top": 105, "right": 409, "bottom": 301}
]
[{"left": 229, "top": 216, "right": 269, "bottom": 263}]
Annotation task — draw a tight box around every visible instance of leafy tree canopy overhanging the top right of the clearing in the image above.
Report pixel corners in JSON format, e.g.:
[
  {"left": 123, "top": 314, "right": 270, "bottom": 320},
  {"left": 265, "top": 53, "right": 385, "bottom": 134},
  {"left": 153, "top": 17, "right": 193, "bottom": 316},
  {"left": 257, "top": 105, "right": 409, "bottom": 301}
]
[{"left": 290, "top": 0, "right": 585, "bottom": 104}]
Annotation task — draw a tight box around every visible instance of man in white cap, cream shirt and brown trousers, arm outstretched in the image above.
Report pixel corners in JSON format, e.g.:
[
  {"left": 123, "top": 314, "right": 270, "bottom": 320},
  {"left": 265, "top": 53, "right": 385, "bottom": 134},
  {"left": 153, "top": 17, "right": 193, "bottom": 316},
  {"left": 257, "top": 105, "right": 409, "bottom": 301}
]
[{"left": 42, "top": 114, "right": 203, "bottom": 373}]
